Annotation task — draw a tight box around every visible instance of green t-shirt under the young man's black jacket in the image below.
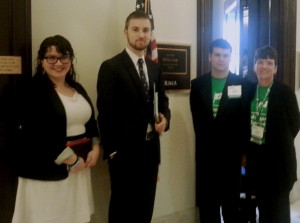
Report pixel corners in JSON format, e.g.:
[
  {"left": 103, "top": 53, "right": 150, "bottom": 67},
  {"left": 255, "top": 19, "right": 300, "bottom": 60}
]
[{"left": 211, "top": 77, "right": 227, "bottom": 117}]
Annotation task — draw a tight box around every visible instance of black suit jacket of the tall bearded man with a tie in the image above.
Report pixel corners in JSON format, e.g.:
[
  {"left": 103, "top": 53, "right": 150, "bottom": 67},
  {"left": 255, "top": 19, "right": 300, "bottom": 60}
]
[{"left": 97, "top": 50, "right": 170, "bottom": 161}]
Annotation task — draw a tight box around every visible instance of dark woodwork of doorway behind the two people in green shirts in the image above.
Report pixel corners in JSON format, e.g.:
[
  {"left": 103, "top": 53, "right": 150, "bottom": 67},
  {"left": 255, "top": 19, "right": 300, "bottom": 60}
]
[{"left": 197, "top": 0, "right": 297, "bottom": 89}]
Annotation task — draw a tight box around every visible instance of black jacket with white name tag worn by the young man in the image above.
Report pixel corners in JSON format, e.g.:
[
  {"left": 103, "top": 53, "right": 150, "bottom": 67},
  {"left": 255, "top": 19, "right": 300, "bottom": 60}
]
[{"left": 190, "top": 73, "right": 251, "bottom": 166}]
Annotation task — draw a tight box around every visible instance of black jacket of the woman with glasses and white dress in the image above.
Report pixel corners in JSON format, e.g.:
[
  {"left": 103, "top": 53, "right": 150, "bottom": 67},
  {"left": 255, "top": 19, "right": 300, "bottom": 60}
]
[{"left": 16, "top": 76, "right": 99, "bottom": 180}]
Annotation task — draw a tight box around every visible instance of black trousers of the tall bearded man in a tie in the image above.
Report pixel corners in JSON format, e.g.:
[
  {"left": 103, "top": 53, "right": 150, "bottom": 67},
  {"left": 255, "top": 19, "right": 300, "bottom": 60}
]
[{"left": 109, "top": 141, "right": 158, "bottom": 223}]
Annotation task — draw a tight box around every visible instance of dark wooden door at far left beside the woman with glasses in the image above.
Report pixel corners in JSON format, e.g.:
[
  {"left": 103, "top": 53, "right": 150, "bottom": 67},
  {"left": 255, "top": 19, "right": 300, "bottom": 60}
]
[{"left": 0, "top": 0, "right": 31, "bottom": 223}]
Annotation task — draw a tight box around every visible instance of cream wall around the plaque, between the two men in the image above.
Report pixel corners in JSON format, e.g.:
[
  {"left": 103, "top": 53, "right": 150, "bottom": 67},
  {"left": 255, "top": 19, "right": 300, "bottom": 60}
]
[{"left": 151, "top": 0, "right": 197, "bottom": 220}]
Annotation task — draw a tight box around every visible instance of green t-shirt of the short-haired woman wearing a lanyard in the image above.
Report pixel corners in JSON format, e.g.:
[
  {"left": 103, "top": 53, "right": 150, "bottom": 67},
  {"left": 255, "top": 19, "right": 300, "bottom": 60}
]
[{"left": 251, "top": 86, "right": 271, "bottom": 144}]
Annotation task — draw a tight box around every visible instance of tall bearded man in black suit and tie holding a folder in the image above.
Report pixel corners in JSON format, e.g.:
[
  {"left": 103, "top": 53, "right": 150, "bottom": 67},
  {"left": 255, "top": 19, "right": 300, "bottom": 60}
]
[{"left": 97, "top": 11, "right": 170, "bottom": 223}]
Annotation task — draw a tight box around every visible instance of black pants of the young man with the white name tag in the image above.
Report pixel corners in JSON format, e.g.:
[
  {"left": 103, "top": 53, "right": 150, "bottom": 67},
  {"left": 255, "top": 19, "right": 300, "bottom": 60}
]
[{"left": 197, "top": 166, "right": 240, "bottom": 223}]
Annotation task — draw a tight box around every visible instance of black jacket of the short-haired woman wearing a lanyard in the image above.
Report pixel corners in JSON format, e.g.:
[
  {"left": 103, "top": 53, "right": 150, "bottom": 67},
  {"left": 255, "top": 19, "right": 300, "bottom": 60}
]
[{"left": 247, "top": 81, "right": 300, "bottom": 191}]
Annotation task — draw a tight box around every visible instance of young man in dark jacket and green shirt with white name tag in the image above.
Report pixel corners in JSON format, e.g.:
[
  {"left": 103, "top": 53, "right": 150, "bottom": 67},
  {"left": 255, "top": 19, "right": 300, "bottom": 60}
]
[{"left": 190, "top": 39, "right": 250, "bottom": 223}]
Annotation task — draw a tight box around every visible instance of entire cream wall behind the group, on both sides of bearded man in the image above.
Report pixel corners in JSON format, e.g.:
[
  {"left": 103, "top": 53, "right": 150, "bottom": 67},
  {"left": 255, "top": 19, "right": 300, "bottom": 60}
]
[{"left": 31, "top": 0, "right": 197, "bottom": 223}]
